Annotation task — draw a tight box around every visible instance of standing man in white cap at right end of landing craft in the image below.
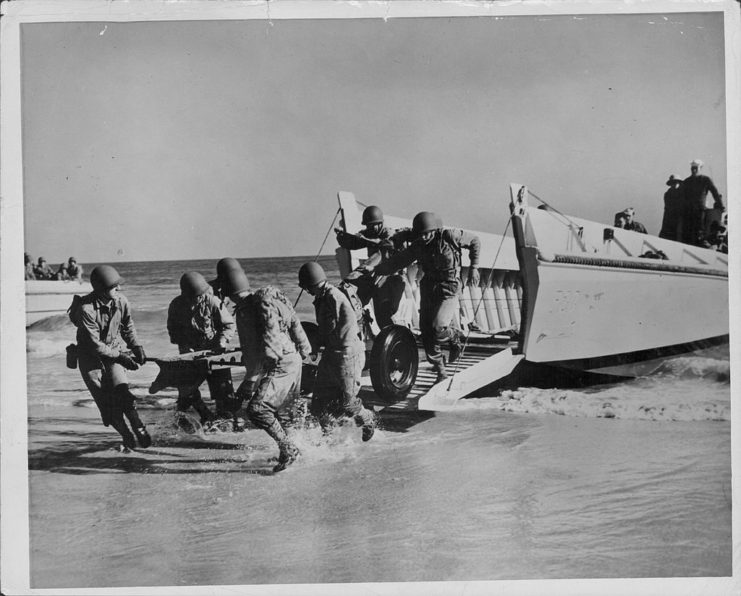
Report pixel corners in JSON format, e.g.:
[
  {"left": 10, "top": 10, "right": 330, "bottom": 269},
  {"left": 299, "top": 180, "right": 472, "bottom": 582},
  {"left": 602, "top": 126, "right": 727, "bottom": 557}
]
[{"left": 682, "top": 159, "right": 725, "bottom": 246}]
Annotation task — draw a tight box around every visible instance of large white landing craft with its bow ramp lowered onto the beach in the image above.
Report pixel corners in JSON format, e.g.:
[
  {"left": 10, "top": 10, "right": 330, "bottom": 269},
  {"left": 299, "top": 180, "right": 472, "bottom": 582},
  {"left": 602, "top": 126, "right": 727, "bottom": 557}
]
[{"left": 336, "top": 184, "right": 729, "bottom": 410}]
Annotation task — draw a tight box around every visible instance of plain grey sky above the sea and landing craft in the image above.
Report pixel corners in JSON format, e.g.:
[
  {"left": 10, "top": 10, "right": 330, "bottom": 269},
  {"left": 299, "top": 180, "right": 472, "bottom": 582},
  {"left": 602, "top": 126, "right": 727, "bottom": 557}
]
[{"left": 21, "top": 5, "right": 727, "bottom": 263}]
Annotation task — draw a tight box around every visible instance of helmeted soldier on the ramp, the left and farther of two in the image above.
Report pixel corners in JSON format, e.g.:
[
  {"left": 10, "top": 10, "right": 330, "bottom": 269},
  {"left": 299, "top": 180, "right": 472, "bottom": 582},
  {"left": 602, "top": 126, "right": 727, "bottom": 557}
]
[{"left": 335, "top": 205, "right": 405, "bottom": 328}]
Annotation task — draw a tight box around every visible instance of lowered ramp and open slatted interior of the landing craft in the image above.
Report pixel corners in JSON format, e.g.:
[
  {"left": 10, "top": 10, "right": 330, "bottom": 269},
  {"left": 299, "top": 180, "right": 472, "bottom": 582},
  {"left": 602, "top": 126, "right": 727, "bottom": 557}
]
[{"left": 336, "top": 192, "right": 522, "bottom": 411}]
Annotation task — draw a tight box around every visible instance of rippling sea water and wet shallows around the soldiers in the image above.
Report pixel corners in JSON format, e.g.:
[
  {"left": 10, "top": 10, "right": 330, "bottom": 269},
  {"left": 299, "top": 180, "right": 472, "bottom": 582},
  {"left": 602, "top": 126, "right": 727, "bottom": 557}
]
[{"left": 27, "top": 258, "right": 732, "bottom": 588}]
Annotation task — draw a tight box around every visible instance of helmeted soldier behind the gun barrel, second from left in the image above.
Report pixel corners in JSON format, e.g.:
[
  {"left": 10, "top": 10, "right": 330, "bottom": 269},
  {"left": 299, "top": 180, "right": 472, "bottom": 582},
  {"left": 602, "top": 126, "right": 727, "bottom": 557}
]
[{"left": 167, "top": 271, "right": 234, "bottom": 424}]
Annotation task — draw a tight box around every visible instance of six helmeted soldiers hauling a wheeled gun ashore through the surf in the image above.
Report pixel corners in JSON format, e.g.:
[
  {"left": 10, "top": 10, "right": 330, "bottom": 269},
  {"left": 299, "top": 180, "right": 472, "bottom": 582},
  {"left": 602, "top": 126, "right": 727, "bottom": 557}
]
[{"left": 68, "top": 207, "right": 480, "bottom": 471}]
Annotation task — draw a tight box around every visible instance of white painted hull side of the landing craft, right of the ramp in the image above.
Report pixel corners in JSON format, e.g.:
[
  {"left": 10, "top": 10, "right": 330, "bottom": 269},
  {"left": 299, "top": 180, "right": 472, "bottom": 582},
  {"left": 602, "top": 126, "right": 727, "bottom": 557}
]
[{"left": 513, "top": 184, "right": 729, "bottom": 376}]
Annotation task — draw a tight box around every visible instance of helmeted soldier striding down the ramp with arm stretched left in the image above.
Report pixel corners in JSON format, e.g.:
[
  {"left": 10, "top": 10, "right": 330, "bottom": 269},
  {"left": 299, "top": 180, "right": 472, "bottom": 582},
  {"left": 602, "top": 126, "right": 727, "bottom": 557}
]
[{"left": 364, "top": 211, "right": 481, "bottom": 382}]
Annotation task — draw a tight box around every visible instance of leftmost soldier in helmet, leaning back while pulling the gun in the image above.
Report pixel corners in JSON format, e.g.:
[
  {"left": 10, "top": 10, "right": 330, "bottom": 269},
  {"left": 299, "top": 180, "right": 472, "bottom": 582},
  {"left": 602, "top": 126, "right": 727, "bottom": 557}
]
[{"left": 69, "top": 265, "right": 152, "bottom": 451}]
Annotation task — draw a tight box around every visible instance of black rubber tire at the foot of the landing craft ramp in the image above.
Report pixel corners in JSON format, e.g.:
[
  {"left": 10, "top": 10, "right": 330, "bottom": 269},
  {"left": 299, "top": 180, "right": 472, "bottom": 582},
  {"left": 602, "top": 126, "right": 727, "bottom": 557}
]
[{"left": 370, "top": 325, "right": 419, "bottom": 402}]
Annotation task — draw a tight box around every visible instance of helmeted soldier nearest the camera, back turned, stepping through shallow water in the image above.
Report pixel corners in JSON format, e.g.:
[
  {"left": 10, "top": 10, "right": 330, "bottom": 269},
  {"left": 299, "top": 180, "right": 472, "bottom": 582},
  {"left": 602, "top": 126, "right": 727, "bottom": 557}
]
[{"left": 223, "top": 269, "right": 311, "bottom": 472}]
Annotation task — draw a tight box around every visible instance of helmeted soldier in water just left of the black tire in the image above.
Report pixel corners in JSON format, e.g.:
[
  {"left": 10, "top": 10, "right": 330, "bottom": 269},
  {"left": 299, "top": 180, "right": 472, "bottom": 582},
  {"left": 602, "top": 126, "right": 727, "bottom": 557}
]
[{"left": 298, "top": 261, "right": 376, "bottom": 441}]
